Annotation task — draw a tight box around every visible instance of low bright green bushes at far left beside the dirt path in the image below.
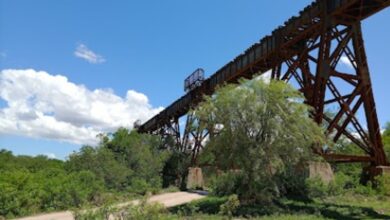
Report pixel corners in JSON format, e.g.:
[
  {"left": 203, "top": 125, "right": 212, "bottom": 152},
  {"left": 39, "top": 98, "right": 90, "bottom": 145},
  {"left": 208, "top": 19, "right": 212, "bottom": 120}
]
[{"left": 0, "top": 150, "right": 102, "bottom": 217}]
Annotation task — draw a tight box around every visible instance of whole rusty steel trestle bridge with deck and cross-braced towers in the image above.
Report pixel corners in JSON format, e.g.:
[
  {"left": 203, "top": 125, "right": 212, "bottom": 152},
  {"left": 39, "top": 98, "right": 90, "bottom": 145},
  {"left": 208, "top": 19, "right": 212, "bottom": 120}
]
[{"left": 139, "top": 0, "right": 390, "bottom": 169}]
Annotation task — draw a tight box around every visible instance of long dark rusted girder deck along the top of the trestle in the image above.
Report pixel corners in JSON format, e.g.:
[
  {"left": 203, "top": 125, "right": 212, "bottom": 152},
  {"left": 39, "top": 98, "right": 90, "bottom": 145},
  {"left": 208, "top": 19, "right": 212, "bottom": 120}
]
[{"left": 139, "top": 0, "right": 390, "bottom": 132}]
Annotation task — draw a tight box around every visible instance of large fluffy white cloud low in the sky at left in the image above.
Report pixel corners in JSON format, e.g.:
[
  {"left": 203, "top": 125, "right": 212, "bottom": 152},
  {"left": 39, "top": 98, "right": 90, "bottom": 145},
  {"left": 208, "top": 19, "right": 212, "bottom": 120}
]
[{"left": 0, "top": 69, "right": 162, "bottom": 144}]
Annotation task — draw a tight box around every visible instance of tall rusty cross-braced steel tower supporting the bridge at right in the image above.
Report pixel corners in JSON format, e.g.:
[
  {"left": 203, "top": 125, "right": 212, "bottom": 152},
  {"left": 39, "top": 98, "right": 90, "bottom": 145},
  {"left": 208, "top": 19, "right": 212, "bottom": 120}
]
[{"left": 271, "top": 21, "right": 388, "bottom": 166}]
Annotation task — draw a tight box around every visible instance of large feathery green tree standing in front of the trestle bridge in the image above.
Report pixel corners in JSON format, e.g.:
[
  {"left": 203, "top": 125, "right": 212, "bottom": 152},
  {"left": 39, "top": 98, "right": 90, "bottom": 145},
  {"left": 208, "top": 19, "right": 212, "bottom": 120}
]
[{"left": 194, "top": 80, "right": 325, "bottom": 202}]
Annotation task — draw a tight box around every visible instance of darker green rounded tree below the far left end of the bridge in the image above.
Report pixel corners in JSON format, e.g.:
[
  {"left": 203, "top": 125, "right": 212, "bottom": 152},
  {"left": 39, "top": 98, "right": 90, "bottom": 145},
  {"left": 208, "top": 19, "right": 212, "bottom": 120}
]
[{"left": 65, "top": 128, "right": 169, "bottom": 194}]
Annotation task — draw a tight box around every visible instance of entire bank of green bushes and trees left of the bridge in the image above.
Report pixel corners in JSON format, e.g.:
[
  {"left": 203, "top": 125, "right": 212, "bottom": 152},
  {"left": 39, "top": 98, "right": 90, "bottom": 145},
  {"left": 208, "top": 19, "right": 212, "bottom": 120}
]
[{"left": 0, "top": 129, "right": 169, "bottom": 218}]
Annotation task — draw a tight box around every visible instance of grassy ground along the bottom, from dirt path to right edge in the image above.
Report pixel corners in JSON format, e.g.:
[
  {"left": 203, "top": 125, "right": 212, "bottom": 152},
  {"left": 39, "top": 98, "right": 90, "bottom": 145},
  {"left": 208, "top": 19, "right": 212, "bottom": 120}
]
[{"left": 71, "top": 189, "right": 390, "bottom": 220}]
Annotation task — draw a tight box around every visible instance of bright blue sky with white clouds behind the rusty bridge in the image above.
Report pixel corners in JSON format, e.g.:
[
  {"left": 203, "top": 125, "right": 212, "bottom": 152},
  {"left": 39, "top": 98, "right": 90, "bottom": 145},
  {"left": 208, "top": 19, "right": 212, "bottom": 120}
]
[{"left": 0, "top": 0, "right": 390, "bottom": 159}]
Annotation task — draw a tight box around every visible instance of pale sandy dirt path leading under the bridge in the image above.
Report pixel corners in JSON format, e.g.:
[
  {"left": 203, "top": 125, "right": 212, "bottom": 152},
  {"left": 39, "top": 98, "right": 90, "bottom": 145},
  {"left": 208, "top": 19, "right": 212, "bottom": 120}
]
[{"left": 19, "top": 192, "right": 205, "bottom": 220}]
